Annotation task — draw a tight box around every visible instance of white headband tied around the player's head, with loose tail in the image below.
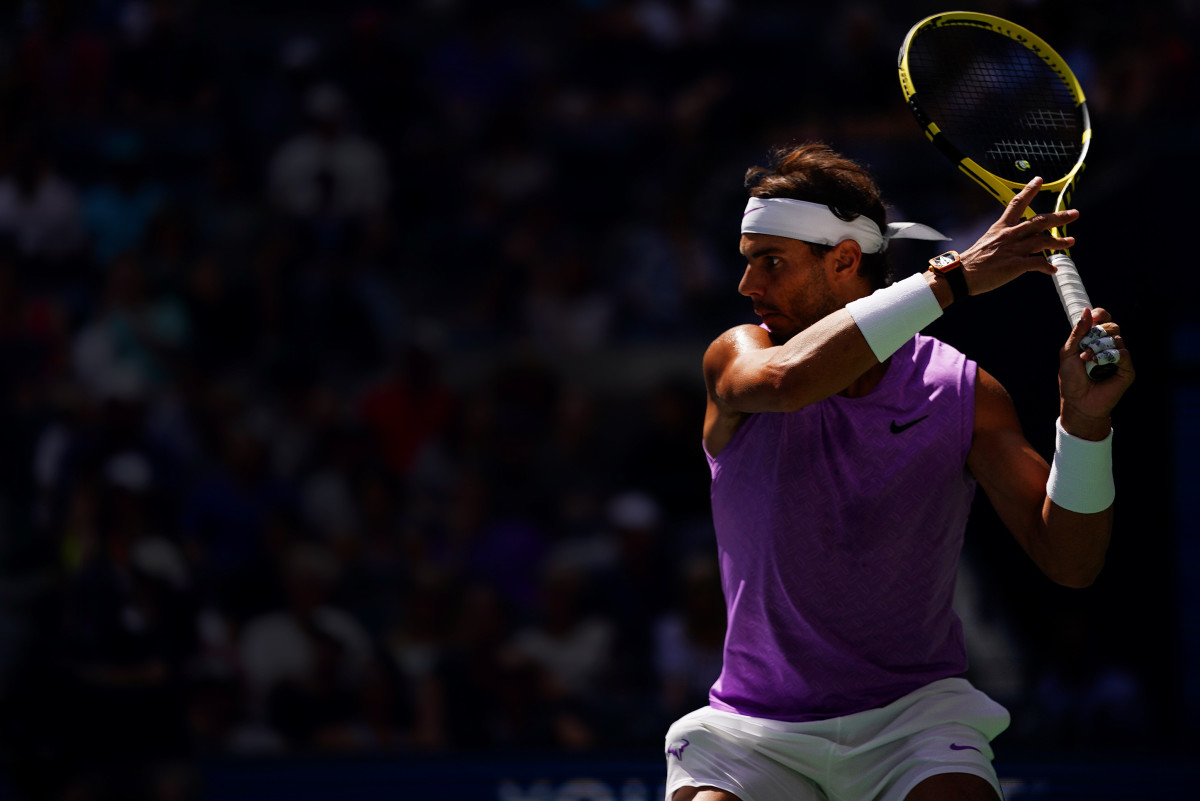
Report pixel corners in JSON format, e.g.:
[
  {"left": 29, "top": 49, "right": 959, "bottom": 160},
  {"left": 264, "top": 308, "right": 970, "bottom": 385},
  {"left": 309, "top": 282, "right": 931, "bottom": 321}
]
[{"left": 742, "top": 198, "right": 950, "bottom": 253}]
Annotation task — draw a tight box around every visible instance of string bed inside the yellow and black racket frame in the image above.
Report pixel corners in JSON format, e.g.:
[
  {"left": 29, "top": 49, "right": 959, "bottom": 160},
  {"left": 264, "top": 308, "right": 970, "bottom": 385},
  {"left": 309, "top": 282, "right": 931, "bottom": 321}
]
[{"left": 908, "top": 25, "right": 1085, "bottom": 182}]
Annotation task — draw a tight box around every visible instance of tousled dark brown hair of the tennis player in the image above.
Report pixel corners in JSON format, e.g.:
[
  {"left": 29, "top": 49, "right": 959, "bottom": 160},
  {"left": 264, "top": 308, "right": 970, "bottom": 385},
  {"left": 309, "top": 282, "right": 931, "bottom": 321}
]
[{"left": 745, "top": 143, "right": 892, "bottom": 289}]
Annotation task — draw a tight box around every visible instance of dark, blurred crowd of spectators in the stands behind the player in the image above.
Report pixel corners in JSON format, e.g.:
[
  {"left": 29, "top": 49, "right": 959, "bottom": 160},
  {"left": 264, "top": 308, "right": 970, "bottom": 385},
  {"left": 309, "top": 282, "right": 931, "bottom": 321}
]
[{"left": 0, "top": 0, "right": 1200, "bottom": 800}]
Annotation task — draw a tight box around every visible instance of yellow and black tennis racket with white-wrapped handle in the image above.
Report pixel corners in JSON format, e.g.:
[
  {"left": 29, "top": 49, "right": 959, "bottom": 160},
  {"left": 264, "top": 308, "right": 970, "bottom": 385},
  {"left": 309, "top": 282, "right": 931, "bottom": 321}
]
[{"left": 899, "top": 11, "right": 1116, "bottom": 380}]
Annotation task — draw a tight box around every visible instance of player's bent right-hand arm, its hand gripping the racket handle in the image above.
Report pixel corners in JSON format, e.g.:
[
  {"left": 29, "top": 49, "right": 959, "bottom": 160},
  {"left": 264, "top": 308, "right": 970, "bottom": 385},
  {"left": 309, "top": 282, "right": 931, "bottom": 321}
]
[{"left": 967, "top": 309, "right": 1134, "bottom": 586}]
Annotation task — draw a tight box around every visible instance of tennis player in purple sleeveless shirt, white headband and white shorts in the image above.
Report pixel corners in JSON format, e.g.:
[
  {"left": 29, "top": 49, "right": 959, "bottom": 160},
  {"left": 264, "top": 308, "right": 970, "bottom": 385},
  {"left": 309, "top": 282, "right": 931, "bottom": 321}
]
[{"left": 666, "top": 145, "right": 1134, "bottom": 801}]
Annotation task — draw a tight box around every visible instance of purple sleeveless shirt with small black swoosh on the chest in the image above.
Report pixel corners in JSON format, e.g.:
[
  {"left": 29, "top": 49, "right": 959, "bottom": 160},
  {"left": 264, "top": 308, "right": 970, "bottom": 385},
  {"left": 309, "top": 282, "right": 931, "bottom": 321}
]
[{"left": 708, "top": 336, "right": 976, "bottom": 721}]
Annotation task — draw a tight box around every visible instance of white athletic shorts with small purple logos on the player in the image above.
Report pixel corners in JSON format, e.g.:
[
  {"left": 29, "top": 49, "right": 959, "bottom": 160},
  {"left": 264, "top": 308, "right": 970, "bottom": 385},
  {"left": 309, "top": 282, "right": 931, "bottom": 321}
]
[{"left": 666, "top": 679, "right": 1009, "bottom": 801}]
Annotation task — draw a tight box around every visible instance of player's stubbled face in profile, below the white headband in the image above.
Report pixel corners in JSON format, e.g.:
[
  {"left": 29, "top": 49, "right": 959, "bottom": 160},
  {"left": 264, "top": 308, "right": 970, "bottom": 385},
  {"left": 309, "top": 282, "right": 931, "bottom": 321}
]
[{"left": 738, "top": 234, "right": 842, "bottom": 342}]
